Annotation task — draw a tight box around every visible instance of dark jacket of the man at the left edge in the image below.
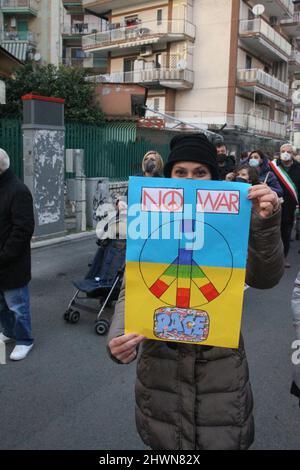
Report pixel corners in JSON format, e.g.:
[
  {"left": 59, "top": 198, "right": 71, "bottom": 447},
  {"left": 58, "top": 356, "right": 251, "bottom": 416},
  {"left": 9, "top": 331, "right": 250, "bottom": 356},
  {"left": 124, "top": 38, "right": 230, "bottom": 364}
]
[{"left": 0, "top": 169, "right": 34, "bottom": 290}]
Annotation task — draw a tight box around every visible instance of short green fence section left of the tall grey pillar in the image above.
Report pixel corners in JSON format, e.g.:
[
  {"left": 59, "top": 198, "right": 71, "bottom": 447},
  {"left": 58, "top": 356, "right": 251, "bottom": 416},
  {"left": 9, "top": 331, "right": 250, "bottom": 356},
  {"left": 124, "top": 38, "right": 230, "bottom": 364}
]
[{"left": 0, "top": 119, "right": 23, "bottom": 178}]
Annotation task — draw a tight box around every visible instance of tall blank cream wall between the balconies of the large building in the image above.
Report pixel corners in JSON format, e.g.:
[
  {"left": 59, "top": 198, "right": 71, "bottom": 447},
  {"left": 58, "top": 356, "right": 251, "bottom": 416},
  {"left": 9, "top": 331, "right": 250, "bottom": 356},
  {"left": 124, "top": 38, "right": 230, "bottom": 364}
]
[{"left": 176, "top": 0, "right": 231, "bottom": 117}]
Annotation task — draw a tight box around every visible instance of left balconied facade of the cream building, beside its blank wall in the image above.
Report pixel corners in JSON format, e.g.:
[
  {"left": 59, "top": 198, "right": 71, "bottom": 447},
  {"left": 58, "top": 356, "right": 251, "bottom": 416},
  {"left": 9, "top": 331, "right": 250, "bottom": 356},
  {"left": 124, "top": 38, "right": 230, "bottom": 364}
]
[{"left": 83, "top": 0, "right": 196, "bottom": 121}]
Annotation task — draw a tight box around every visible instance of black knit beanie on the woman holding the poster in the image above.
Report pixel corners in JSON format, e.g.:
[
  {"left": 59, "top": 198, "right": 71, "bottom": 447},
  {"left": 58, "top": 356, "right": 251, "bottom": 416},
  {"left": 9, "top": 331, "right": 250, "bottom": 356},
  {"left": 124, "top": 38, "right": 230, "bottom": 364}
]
[{"left": 164, "top": 134, "right": 219, "bottom": 180}]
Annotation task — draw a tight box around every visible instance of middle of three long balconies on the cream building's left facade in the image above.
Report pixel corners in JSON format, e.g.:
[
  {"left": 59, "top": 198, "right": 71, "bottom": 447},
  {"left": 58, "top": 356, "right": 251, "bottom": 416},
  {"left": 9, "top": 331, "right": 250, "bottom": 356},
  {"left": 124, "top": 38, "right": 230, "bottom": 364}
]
[{"left": 82, "top": 20, "right": 196, "bottom": 52}]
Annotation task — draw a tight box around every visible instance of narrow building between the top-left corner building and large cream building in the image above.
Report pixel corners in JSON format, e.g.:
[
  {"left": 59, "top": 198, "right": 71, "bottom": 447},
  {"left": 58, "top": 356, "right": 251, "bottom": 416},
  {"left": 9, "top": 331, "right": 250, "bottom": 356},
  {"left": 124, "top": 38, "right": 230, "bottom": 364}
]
[{"left": 61, "top": 0, "right": 107, "bottom": 74}]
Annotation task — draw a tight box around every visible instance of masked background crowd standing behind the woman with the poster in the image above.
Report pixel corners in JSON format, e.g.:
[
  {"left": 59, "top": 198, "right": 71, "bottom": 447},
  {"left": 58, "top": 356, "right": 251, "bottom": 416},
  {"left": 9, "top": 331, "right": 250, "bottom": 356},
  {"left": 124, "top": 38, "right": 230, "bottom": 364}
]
[{"left": 139, "top": 143, "right": 300, "bottom": 268}]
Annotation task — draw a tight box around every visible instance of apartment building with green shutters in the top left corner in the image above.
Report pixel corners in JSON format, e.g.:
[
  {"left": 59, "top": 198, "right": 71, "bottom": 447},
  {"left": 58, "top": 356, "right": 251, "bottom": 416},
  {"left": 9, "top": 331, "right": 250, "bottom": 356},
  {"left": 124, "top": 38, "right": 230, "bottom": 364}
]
[{"left": 0, "top": 0, "right": 62, "bottom": 65}]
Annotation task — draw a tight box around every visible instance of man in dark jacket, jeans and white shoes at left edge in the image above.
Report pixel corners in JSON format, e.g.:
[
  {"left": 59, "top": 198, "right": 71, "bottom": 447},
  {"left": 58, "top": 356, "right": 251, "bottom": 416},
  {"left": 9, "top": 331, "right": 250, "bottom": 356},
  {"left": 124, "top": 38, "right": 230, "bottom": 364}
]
[{"left": 0, "top": 149, "right": 34, "bottom": 361}]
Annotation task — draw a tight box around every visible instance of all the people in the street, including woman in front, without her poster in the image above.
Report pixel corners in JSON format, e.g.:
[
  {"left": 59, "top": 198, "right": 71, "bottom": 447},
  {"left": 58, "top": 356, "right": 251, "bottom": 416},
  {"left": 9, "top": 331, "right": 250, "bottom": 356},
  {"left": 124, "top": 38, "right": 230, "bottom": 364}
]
[{"left": 0, "top": 134, "right": 300, "bottom": 450}]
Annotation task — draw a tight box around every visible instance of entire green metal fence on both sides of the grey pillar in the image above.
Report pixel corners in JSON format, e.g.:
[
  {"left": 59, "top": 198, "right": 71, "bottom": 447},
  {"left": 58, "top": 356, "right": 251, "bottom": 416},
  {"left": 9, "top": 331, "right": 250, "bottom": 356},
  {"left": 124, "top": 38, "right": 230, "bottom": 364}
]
[{"left": 0, "top": 119, "right": 169, "bottom": 181}]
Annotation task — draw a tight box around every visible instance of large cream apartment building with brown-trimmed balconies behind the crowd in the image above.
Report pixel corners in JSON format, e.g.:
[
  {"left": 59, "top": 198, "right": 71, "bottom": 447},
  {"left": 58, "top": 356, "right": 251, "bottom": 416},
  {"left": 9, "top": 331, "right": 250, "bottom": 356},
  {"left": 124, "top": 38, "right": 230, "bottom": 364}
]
[{"left": 79, "top": 0, "right": 300, "bottom": 149}]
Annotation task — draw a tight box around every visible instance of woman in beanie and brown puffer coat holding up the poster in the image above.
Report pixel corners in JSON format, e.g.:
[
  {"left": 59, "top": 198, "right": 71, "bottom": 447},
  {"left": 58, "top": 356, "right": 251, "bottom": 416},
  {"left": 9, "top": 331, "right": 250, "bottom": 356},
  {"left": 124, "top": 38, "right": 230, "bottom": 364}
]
[{"left": 108, "top": 134, "right": 284, "bottom": 450}]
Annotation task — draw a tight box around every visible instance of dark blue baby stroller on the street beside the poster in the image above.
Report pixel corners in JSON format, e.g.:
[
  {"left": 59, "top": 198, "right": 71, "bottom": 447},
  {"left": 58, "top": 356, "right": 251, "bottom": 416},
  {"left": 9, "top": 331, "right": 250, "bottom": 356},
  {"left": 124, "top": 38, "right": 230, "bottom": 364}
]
[{"left": 64, "top": 233, "right": 126, "bottom": 335}]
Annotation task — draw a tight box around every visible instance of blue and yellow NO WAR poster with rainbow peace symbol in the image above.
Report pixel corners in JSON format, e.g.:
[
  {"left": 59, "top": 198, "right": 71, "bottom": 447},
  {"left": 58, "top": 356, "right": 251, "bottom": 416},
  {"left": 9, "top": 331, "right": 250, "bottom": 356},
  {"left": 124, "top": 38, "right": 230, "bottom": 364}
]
[{"left": 125, "top": 177, "right": 251, "bottom": 348}]
